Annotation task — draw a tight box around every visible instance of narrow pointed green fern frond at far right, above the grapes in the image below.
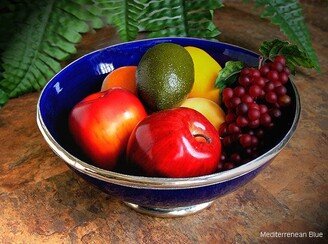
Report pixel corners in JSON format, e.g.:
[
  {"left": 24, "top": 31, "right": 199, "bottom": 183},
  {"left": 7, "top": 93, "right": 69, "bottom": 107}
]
[{"left": 256, "top": 0, "right": 320, "bottom": 71}]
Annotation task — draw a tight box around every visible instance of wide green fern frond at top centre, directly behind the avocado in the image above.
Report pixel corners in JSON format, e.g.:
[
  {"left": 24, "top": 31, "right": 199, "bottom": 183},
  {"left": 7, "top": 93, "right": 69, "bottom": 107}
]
[{"left": 141, "top": 0, "right": 223, "bottom": 38}]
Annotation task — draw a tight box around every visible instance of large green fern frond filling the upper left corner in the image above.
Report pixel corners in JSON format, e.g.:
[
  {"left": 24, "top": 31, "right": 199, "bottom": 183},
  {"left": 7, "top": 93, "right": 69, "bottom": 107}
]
[{"left": 0, "top": 0, "right": 103, "bottom": 99}]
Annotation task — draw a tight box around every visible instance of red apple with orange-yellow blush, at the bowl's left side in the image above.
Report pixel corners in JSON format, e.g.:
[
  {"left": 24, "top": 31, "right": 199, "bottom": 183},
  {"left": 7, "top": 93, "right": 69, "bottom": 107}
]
[{"left": 69, "top": 88, "right": 147, "bottom": 170}]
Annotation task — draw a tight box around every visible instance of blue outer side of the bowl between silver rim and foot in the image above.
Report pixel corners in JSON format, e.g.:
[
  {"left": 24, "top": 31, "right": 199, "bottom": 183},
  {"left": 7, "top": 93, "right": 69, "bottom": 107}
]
[{"left": 73, "top": 161, "right": 270, "bottom": 208}]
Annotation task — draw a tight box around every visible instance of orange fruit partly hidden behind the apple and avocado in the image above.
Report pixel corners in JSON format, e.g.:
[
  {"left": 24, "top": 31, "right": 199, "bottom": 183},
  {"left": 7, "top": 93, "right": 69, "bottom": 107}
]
[{"left": 101, "top": 66, "right": 137, "bottom": 94}]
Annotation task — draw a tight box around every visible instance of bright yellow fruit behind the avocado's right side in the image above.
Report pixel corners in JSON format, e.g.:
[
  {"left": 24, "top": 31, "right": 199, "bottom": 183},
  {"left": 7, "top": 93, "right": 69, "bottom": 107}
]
[{"left": 185, "top": 46, "right": 222, "bottom": 103}]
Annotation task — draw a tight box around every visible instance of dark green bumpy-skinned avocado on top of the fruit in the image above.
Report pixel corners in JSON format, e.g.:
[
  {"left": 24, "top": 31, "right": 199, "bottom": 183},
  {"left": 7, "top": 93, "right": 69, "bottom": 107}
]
[{"left": 137, "top": 43, "right": 194, "bottom": 111}]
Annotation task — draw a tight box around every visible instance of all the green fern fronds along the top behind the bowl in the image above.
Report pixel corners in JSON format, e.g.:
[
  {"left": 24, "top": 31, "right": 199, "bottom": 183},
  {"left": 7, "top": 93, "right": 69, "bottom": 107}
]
[{"left": 0, "top": 0, "right": 320, "bottom": 107}]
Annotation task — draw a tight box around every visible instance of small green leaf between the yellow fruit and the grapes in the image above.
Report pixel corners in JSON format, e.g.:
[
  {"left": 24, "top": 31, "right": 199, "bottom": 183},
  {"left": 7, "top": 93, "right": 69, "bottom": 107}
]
[{"left": 215, "top": 61, "right": 244, "bottom": 91}]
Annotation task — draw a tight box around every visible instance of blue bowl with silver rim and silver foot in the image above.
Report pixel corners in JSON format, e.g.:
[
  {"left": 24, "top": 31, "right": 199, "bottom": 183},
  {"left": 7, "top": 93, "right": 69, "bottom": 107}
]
[{"left": 37, "top": 38, "right": 300, "bottom": 216}]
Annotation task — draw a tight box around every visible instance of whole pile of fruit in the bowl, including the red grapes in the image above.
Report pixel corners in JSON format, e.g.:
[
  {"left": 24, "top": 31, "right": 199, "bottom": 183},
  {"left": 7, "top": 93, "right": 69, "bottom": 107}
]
[{"left": 68, "top": 40, "right": 306, "bottom": 177}]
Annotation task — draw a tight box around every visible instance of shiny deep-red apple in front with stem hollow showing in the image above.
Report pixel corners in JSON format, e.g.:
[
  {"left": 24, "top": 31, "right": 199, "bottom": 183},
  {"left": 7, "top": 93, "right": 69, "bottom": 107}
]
[{"left": 127, "top": 108, "right": 221, "bottom": 178}]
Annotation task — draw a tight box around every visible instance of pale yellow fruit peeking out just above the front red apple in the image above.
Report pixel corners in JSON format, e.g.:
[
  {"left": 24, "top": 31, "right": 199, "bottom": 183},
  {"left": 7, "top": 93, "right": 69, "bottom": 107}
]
[{"left": 181, "top": 97, "right": 225, "bottom": 130}]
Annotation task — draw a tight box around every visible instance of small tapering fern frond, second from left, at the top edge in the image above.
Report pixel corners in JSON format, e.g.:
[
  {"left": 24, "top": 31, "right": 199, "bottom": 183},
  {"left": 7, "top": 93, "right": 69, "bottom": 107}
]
[{"left": 95, "top": 0, "right": 144, "bottom": 41}]
